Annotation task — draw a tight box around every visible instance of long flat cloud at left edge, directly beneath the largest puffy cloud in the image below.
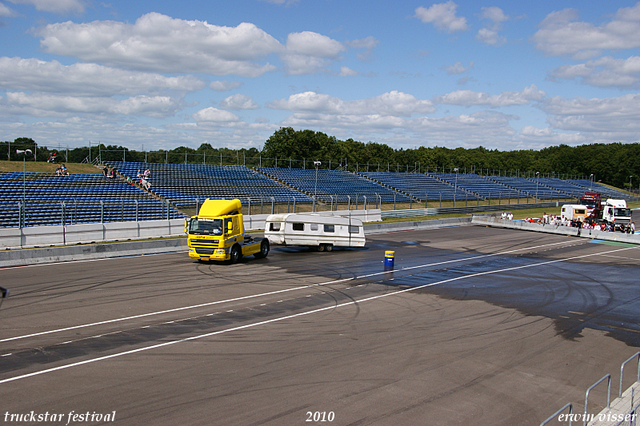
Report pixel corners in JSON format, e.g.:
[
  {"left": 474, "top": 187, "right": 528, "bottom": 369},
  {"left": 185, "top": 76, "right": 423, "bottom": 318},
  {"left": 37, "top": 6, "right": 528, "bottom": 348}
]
[{"left": 0, "top": 57, "right": 205, "bottom": 97}]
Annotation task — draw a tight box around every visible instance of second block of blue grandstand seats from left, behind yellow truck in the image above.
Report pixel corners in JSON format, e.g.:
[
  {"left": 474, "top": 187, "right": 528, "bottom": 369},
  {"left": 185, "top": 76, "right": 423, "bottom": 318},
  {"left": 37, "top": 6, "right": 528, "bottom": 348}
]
[{"left": 105, "top": 161, "right": 311, "bottom": 207}]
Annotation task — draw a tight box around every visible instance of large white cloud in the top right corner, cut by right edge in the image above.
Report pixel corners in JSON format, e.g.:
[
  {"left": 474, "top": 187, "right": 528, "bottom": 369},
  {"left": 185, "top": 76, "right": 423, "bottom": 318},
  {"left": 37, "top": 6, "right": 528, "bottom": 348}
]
[{"left": 532, "top": 3, "right": 640, "bottom": 59}]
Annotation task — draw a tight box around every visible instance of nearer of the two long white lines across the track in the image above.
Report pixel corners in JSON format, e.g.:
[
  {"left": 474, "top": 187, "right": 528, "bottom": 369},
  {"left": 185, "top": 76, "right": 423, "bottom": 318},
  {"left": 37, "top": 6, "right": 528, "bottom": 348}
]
[{"left": 0, "top": 243, "right": 640, "bottom": 384}]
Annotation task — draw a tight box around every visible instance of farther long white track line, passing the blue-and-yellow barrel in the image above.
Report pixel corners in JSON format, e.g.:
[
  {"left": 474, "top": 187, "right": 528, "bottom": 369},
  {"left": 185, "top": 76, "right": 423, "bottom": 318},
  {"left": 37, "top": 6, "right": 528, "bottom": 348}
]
[{"left": 0, "top": 241, "right": 592, "bottom": 343}]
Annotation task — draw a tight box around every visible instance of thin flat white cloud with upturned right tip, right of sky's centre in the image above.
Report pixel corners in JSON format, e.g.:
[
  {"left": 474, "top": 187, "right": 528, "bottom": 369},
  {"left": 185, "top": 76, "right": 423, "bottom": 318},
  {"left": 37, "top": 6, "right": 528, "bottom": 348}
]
[{"left": 434, "top": 84, "right": 546, "bottom": 107}]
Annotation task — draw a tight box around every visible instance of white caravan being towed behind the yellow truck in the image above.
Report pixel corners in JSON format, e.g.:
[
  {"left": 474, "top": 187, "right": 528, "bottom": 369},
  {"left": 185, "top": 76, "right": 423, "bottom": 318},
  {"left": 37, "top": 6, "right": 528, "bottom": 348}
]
[{"left": 264, "top": 213, "right": 365, "bottom": 251}]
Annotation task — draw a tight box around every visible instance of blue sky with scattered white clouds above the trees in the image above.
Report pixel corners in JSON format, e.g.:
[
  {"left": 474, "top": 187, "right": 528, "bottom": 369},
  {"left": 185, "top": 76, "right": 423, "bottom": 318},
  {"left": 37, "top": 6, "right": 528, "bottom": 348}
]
[{"left": 0, "top": 0, "right": 640, "bottom": 151}]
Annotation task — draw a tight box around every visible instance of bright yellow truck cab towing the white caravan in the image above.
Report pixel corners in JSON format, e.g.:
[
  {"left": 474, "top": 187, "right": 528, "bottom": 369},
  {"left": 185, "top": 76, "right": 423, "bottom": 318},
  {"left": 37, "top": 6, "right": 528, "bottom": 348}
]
[{"left": 185, "top": 198, "right": 269, "bottom": 263}]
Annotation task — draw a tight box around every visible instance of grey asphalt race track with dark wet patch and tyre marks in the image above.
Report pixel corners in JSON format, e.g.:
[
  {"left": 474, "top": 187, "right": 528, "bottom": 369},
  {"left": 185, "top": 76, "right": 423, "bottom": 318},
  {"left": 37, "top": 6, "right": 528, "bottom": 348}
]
[{"left": 0, "top": 226, "right": 640, "bottom": 426}]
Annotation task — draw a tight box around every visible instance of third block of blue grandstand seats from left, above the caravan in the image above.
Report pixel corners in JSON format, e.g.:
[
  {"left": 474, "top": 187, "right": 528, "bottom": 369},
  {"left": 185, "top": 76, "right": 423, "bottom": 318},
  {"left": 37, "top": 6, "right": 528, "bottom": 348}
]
[{"left": 257, "top": 167, "right": 410, "bottom": 203}]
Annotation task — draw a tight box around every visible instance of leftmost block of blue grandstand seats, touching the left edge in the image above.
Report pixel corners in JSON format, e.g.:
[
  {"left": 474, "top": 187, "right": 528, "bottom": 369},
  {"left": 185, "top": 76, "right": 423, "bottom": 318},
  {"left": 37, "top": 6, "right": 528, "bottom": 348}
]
[{"left": 0, "top": 172, "right": 183, "bottom": 228}]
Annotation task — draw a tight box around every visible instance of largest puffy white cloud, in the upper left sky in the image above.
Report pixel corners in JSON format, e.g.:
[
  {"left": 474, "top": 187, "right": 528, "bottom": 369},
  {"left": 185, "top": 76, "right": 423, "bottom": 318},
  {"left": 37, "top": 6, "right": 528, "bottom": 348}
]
[{"left": 38, "top": 13, "right": 283, "bottom": 77}]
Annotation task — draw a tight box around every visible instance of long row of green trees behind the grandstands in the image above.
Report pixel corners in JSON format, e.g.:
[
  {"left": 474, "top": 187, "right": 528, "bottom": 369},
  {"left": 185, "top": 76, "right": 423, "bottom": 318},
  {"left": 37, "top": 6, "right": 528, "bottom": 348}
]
[{"left": 0, "top": 127, "right": 640, "bottom": 187}]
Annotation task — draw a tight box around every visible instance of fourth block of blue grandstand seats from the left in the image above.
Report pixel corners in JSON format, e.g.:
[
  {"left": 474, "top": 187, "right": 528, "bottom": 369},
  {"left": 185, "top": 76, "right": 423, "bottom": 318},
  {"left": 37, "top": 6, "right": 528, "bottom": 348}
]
[{"left": 360, "top": 172, "right": 478, "bottom": 201}]
